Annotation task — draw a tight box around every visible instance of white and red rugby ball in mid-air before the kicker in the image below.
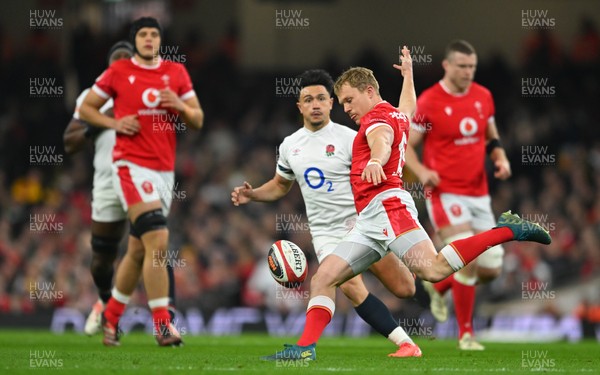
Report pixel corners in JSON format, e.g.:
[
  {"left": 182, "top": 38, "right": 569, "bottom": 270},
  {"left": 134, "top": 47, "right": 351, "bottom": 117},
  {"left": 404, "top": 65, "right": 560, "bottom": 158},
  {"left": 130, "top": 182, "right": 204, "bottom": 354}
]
[{"left": 267, "top": 240, "right": 308, "bottom": 288}]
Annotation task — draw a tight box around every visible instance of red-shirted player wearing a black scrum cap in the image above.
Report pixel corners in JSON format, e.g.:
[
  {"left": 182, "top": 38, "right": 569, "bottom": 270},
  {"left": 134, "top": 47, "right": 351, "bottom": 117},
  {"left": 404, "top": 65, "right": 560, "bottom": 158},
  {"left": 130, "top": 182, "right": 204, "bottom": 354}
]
[{"left": 80, "top": 17, "right": 204, "bottom": 346}]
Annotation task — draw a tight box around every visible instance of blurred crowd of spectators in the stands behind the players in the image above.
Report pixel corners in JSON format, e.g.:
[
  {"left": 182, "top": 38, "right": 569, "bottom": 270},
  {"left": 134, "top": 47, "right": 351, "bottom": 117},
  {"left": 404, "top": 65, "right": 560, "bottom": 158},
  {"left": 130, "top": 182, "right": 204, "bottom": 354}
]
[{"left": 0, "top": 17, "right": 600, "bottom": 324}]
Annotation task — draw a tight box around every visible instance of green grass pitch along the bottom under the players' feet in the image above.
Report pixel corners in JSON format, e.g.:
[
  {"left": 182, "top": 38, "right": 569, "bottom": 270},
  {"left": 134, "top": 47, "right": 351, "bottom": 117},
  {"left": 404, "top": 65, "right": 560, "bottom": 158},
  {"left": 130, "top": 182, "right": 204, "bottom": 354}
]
[{"left": 0, "top": 330, "right": 600, "bottom": 375}]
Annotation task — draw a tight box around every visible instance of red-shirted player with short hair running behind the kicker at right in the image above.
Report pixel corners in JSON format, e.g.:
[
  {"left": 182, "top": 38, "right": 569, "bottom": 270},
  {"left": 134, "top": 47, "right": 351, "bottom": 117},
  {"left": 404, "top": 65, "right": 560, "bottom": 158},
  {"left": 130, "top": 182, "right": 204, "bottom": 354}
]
[{"left": 406, "top": 40, "right": 511, "bottom": 350}]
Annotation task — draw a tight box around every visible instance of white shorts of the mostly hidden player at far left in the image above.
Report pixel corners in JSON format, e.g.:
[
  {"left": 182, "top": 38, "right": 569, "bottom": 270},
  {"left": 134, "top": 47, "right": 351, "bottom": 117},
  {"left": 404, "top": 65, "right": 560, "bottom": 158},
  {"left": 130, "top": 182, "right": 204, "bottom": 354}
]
[{"left": 92, "top": 172, "right": 127, "bottom": 223}]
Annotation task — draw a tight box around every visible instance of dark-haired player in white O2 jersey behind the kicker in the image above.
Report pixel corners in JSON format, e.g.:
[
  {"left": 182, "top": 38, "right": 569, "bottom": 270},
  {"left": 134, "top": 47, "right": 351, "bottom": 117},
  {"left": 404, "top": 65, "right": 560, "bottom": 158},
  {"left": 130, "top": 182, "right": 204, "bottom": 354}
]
[{"left": 231, "top": 70, "right": 421, "bottom": 357}]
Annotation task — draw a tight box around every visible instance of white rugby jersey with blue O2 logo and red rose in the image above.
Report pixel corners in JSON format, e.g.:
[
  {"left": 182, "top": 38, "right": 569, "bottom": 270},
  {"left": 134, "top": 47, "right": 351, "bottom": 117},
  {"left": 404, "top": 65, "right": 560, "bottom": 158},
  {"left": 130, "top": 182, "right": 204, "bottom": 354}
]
[{"left": 277, "top": 121, "right": 356, "bottom": 238}]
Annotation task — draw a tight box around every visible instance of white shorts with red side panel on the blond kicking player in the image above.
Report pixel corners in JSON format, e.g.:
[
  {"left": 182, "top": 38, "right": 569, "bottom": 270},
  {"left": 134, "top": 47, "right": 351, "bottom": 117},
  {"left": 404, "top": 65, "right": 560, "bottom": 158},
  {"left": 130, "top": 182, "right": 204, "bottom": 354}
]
[{"left": 333, "top": 189, "right": 430, "bottom": 275}]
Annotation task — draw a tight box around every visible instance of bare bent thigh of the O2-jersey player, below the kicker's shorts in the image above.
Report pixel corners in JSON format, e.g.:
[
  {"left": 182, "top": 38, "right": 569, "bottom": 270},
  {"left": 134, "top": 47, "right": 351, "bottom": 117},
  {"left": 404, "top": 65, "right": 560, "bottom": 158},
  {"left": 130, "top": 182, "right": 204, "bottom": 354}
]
[{"left": 369, "top": 253, "right": 415, "bottom": 298}]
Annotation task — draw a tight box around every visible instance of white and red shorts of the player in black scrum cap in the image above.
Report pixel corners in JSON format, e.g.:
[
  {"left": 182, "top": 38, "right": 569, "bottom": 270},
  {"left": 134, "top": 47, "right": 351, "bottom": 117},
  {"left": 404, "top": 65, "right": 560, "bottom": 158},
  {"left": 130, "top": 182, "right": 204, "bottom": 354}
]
[{"left": 113, "top": 160, "right": 175, "bottom": 216}]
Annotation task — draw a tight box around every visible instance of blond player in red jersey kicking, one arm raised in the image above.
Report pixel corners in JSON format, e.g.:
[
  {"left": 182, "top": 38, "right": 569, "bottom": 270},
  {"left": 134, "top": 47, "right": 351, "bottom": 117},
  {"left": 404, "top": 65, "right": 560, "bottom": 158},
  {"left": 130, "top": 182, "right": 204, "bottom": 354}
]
[{"left": 262, "top": 46, "right": 552, "bottom": 361}]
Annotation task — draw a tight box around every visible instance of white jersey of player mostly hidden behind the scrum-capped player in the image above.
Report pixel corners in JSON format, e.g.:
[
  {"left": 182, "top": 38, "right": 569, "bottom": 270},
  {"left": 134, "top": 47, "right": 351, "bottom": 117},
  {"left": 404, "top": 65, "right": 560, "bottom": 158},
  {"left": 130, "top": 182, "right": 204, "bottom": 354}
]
[{"left": 73, "top": 89, "right": 116, "bottom": 195}]
